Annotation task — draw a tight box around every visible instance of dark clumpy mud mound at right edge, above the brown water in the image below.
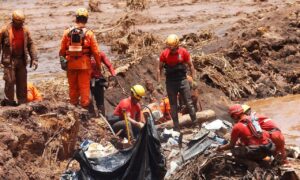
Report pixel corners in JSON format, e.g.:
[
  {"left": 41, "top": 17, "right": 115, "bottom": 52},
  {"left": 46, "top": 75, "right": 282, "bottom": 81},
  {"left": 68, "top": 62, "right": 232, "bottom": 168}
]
[{"left": 224, "top": 7, "right": 300, "bottom": 98}]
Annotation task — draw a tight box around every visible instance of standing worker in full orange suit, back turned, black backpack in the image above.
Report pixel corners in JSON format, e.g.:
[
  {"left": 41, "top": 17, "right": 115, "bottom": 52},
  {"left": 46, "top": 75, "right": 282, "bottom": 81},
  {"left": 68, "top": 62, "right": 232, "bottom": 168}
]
[{"left": 59, "top": 8, "right": 100, "bottom": 109}]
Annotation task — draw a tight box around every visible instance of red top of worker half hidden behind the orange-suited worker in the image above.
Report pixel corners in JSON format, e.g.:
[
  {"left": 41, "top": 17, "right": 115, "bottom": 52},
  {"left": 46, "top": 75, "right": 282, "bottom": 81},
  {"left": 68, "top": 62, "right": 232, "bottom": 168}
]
[{"left": 91, "top": 51, "right": 116, "bottom": 79}]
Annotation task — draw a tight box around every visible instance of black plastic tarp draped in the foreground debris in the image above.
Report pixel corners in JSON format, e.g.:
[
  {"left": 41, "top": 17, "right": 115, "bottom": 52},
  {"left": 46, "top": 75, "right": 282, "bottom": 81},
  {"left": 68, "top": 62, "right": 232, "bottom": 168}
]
[{"left": 61, "top": 116, "right": 166, "bottom": 180}]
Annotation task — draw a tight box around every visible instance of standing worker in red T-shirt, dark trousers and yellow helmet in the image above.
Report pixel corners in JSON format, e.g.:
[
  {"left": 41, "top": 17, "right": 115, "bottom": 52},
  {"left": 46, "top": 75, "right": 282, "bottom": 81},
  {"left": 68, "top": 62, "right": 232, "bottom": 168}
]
[{"left": 157, "top": 34, "right": 196, "bottom": 131}]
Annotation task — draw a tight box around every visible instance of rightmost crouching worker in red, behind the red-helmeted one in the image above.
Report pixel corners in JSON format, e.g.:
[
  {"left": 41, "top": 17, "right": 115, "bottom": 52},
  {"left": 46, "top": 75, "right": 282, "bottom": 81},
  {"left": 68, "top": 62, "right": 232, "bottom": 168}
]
[{"left": 242, "top": 105, "right": 288, "bottom": 164}]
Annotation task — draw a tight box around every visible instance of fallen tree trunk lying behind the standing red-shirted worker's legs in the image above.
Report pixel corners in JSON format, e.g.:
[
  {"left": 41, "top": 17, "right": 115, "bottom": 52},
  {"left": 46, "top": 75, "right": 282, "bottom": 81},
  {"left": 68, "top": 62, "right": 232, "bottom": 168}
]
[{"left": 156, "top": 109, "right": 216, "bottom": 129}]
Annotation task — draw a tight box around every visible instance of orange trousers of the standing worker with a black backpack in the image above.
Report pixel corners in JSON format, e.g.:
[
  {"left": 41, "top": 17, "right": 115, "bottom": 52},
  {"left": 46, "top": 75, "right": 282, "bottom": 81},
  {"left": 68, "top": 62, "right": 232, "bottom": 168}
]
[{"left": 67, "top": 69, "right": 91, "bottom": 108}]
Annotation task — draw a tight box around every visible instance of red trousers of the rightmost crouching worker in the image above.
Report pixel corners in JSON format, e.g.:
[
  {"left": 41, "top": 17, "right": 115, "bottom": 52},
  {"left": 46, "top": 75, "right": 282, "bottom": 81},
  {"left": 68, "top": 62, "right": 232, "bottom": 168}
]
[{"left": 270, "top": 131, "right": 286, "bottom": 161}]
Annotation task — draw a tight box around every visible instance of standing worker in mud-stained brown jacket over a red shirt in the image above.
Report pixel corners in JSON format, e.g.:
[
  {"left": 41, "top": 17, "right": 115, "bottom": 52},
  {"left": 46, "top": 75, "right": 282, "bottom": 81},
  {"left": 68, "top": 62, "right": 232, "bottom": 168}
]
[{"left": 0, "top": 10, "right": 38, "bottom": 105}]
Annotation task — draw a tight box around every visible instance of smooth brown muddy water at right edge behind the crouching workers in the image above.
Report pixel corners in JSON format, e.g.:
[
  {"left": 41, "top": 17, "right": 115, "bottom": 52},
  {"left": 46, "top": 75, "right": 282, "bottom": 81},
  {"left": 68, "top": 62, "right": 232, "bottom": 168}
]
[{"left": 247, "top": 95, "right": 300, "bottom": 146}]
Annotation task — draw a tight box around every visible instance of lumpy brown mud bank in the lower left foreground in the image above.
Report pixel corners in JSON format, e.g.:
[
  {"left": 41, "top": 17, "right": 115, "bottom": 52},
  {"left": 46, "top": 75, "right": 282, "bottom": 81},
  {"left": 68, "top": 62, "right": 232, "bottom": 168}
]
[{"left": 0, "top": 100, "right": 110, "bottom": 179}]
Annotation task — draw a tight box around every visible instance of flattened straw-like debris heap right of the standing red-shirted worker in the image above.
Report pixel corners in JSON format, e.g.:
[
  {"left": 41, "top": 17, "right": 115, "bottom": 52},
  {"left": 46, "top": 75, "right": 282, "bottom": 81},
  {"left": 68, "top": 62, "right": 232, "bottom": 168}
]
[{"left": 193, "top": 54, "right": 255, "bottom": 99}]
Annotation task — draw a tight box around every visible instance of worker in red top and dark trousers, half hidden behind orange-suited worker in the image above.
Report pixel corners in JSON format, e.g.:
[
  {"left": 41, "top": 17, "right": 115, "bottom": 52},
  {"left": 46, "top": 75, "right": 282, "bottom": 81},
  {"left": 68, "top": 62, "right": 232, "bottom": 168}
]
[{"left": 91, "top": 52, "right": 116, "bottom": 116}]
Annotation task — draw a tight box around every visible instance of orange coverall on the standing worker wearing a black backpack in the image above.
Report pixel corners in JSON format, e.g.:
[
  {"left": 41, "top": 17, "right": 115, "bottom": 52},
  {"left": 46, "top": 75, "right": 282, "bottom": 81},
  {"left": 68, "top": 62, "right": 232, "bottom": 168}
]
[{"left": 59, "top": 26, "right": 100, "bottom": 108}]
